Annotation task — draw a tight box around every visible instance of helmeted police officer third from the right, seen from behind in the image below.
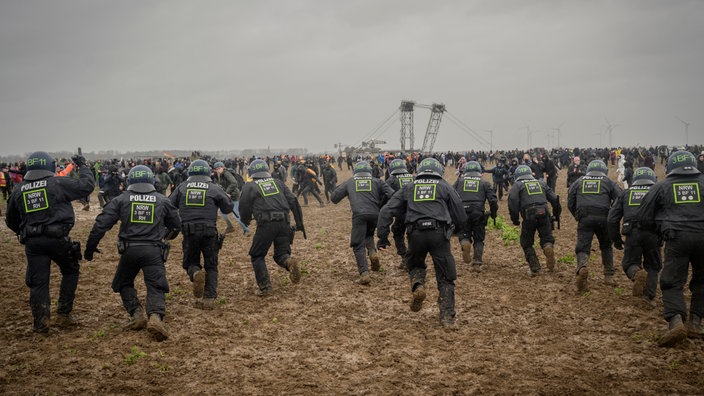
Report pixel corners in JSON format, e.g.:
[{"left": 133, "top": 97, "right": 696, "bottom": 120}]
[{"left": 567, "top": 160, "right": 622, "bottom": 293}]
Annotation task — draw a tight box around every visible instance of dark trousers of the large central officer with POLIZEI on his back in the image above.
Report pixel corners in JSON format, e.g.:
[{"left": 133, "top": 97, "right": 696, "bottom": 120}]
[{"left": 408, "top": 228, "right": 457, "bottom": 317}]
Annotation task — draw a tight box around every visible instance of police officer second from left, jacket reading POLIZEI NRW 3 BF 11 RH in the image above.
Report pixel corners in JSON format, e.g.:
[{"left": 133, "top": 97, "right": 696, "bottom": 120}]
[{"left": 84, "top": 165, "right": 181, "bottom": 341}]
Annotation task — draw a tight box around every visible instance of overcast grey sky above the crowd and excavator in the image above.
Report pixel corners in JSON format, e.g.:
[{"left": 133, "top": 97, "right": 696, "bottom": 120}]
[{"left": 0, "top": 0, "right": 704, "bottom": 155}]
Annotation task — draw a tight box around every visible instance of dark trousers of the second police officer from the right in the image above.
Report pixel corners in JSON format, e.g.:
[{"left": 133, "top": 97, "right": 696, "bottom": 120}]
[{"left": 621, "top": 228, "right": 662, "bottom": 299}]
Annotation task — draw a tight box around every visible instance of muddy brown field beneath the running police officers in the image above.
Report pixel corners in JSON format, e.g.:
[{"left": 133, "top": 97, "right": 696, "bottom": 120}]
[{"left": 0, "top": 162, "right": 704, "bottom": 395}]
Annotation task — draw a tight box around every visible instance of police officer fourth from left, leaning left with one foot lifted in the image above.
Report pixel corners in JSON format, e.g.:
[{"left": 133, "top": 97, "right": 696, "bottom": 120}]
[{"left": 240, "top": 159, "right": 305, "bottom": 296}]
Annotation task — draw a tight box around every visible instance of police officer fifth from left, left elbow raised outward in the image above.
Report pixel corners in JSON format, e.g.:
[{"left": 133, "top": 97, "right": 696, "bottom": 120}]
[{"left": 331, "top": 161, "right": 394, "bottom": 285}]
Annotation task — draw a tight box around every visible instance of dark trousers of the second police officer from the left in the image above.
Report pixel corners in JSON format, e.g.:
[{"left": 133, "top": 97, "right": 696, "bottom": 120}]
[{"left": 112, "top": 245, "right": 169, "bottom": 317}]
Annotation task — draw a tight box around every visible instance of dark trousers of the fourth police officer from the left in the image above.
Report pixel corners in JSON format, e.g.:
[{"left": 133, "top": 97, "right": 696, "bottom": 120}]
[{"left": 249, "top": 221, "right": 291, "bottom": 289}]
